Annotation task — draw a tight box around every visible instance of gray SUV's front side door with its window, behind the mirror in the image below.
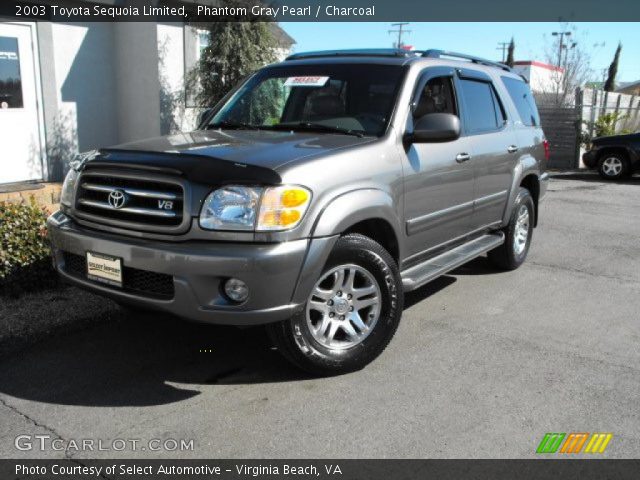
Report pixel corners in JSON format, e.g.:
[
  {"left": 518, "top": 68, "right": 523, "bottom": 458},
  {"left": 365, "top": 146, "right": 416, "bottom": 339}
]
[{"left": 404, "top": 67, "right": 474, "bottom": 256}]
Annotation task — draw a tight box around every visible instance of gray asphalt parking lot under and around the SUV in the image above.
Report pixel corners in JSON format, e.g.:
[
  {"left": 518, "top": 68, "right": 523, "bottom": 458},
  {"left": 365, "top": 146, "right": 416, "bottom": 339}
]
[{"left": 0, "top": 174, "right": 640, "bottom": 458}]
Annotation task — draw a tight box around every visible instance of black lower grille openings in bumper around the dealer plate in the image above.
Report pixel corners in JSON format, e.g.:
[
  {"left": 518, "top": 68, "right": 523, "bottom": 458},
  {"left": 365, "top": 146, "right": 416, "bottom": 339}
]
[{"left": 63, "top": 252, "right": 174, "bottom": 299}]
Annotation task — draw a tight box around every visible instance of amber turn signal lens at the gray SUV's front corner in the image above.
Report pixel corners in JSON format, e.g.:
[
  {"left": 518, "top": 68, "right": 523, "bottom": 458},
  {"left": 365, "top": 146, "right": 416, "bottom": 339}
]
[{"left": 256, "top": 185, "right": 311, "bottom": 231}]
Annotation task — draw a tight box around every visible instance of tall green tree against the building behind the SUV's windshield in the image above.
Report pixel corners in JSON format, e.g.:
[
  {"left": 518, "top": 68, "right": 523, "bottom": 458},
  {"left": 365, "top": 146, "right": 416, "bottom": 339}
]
[{"left": 188, "top": 21, "right": 278, "bottom": 107}]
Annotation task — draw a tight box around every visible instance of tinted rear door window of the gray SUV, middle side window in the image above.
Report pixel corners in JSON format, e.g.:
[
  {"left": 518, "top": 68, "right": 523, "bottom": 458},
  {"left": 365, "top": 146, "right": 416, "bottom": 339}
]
[{"left": 460, "top": 79, "right": 505, "bottom": 133}]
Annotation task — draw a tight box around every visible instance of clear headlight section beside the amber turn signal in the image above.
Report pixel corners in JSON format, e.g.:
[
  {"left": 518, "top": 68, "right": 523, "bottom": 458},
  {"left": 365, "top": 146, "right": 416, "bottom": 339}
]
[{"left": 200, "top": 185, "right": 262, "bottom": 230}]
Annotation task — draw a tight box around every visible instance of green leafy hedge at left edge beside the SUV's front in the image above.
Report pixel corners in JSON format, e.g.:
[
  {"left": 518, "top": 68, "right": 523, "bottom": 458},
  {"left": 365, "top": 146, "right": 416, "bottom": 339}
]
[{"left": 0, "top": 198, "right": 57, "bottom": 295}]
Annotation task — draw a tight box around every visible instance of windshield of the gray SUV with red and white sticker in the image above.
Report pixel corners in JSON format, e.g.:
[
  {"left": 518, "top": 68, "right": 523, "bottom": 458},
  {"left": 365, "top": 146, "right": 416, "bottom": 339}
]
[{"left": 208, "top": 64, "right": 404, "bottom": 136}]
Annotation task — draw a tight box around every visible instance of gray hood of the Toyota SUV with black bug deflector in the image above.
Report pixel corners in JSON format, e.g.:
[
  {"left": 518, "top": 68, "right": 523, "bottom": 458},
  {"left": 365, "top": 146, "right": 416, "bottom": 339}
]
[{"left": 86, "top": 130, "right": 377, "bottom": 183}]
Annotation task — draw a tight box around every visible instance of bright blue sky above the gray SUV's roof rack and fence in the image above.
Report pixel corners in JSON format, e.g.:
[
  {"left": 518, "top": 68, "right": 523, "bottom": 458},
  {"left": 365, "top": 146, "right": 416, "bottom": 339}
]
[{"left": 280, "top": 22, "right": 640, "bottom": 82}]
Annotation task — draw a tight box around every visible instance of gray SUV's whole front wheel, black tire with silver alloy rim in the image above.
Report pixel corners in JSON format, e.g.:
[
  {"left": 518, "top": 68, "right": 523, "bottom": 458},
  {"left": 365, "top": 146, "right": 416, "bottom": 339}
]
[{"left": 268, "top": 234, "right": 403, "bottom": 375}]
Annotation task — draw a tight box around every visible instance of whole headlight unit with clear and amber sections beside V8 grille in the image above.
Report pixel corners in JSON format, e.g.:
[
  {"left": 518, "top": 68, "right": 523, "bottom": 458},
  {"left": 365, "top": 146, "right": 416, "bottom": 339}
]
[{"left": 200, "top": 185, "right": 311, "bottom": 231}]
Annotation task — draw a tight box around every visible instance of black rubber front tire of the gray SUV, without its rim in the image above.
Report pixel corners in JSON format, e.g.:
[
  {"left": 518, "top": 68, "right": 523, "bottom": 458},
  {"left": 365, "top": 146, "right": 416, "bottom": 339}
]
[{"left": 267, "top": 234, "right": 404, "bottom": 376}]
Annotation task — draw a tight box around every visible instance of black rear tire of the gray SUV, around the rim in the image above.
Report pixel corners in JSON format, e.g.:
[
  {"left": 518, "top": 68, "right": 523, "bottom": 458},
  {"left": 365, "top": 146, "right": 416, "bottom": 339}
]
[{"left": 489, "top": 187, "right": 535, "bottom": 270}]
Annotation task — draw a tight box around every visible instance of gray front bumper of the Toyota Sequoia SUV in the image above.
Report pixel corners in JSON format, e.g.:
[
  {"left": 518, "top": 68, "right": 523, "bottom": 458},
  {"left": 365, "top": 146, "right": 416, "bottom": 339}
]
[{"left": 47, "top": 212, "right": 335, "bottom": 325}]
